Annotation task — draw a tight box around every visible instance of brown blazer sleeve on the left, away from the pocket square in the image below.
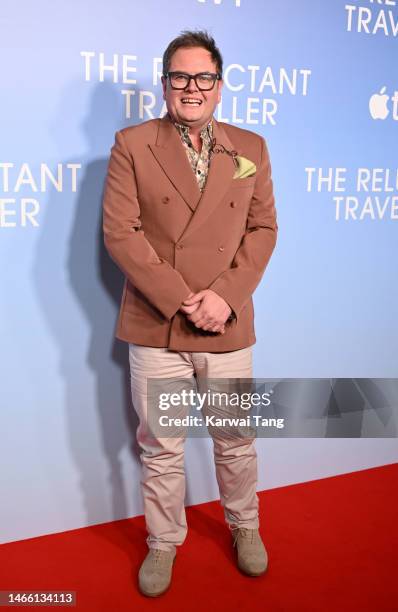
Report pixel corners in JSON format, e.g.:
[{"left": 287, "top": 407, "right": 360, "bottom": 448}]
[{"left": 103, "top": 132, "right": 191, "bottom": 320}]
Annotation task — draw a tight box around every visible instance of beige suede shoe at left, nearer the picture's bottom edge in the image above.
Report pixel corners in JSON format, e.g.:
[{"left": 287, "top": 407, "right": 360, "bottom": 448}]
[{"left": 138, "top": 548, "right": 176, "bottom": 597}]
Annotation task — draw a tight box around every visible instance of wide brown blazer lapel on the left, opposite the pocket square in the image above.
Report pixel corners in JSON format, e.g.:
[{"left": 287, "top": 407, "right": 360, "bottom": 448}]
[{"left": 149, "top": 115, "right": 201, "bottom": 211}]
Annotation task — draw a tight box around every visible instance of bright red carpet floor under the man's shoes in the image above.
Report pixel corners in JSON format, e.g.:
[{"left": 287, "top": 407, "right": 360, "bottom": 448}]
[{"left": 0, "top": 464, "right": 398, "bottom": 612}]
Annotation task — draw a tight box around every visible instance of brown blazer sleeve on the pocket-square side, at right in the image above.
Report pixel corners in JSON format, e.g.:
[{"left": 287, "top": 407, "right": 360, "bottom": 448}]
[{"left": 209, "top": 137, "right": 278, "bottom": 319}]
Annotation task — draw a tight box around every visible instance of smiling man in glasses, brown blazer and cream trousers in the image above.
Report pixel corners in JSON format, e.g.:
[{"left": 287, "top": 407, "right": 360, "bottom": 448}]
[{"left": 103, "top": 31, "right": 278, "bottom": 596}]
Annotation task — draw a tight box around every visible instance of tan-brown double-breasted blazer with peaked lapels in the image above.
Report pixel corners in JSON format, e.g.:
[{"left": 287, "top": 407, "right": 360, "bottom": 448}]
[{"left": 103, "top": 115, "right": 278, "bottom": 352}]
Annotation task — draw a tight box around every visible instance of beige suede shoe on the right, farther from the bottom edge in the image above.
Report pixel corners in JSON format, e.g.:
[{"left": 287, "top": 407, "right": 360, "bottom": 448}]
[{"left": 232, "top": 527, "right": 268, "bottom": 576}]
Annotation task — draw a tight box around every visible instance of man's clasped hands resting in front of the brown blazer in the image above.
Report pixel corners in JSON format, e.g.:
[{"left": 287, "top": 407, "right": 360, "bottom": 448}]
[{"left": 180, "top": 289, "right": 232, "bottom": 334}]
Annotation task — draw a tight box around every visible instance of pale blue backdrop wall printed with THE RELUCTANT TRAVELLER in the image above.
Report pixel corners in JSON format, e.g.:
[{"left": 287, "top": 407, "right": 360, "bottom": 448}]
[{"left": 0, "top": 0, "right": 398, "bottom": 541}]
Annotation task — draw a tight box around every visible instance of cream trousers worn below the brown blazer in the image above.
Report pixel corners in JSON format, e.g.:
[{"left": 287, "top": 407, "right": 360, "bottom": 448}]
[{"left": 129, "top": 344, "right": 259, "bottom": 551}]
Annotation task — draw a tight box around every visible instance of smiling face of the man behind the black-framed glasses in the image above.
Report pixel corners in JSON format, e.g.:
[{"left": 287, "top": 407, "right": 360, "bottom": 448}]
[{"left": 162, "top": 47, "right": 222, "bottom": 128}]
